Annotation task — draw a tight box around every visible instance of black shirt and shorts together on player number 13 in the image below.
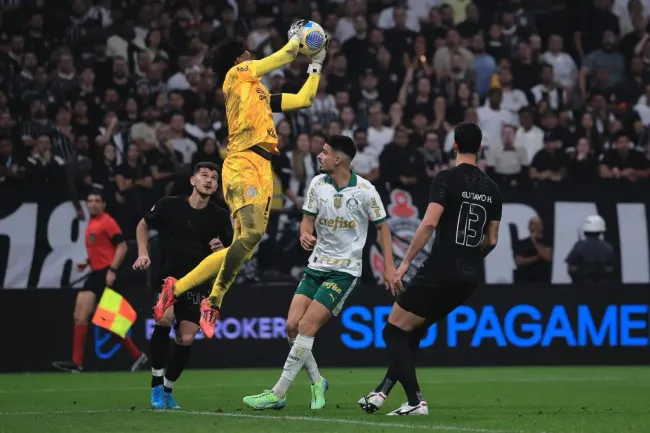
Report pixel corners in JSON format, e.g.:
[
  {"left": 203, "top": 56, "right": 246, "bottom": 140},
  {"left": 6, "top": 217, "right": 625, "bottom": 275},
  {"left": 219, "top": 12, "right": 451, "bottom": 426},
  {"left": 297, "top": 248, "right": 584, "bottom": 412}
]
[{"left": 397, "top": 164, "right": 502, "bottom": 323}]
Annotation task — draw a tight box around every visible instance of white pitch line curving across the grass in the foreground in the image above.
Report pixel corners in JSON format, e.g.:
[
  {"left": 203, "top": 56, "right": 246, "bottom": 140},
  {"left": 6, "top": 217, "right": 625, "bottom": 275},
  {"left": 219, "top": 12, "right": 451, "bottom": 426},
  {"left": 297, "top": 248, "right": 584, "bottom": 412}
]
[{"left": 0, "top": 409, "right": 523, "bottom": 433}]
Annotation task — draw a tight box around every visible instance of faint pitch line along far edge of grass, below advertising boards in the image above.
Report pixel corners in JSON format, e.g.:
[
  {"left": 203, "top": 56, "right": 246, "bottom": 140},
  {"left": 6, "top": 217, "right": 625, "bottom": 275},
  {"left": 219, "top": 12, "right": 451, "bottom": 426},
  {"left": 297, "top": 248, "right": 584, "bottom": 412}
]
[{"left": 0, "top": 376, "right": 621, "bottom": 394}]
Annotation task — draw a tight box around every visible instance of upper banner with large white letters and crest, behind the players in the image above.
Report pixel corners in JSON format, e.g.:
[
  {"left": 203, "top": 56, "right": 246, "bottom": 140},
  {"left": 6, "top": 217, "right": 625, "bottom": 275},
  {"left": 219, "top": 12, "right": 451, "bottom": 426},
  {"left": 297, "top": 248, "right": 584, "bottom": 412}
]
[{"left": 0, "top": 183, "right": 650, "bottom": 289}]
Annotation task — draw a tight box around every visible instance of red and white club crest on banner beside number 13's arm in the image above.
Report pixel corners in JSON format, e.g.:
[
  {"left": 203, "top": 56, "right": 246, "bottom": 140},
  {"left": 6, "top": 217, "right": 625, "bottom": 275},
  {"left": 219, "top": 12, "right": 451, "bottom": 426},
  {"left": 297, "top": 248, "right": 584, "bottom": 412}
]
[{"left": 370, "top": 189, "right": 433, "bottom": 282}]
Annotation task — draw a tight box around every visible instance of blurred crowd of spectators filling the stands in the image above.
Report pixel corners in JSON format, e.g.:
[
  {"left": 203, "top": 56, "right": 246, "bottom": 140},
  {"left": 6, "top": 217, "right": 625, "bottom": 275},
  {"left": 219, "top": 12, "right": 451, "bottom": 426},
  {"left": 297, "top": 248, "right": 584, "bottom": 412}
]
[{"left": 0, "top": 0, "right": 650, "bottom": 278}]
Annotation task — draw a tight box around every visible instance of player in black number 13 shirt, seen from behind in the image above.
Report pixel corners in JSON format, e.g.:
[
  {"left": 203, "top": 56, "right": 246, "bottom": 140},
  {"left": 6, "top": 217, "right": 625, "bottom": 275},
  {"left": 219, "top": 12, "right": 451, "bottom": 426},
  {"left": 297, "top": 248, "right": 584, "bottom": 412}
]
[{"left": 358, "top": 122, "right": 502, "bottom": 415}]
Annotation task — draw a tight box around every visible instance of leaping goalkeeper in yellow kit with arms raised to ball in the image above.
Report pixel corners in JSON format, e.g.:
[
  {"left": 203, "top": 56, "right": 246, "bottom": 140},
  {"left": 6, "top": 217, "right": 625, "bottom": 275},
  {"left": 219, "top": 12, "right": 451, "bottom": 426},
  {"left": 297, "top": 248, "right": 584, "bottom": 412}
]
[{"left": 154, "top": 20, "right": 327, "bottom": 338}]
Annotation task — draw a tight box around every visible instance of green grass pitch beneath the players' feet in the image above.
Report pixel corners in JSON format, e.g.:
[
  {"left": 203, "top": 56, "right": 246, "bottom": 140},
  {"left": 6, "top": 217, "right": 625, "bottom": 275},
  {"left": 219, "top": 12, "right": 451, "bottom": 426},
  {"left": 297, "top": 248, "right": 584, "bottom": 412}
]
[{"left": 0, "top": 367, "right": 650, "bottom": 433}]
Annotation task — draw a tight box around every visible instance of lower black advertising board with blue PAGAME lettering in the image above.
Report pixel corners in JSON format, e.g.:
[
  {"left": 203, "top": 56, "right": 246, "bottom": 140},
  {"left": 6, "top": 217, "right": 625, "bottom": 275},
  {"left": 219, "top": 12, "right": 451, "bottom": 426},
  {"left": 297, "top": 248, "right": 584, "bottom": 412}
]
[{"left": 0, "top": 284, "right": 650, "bottom": 372}]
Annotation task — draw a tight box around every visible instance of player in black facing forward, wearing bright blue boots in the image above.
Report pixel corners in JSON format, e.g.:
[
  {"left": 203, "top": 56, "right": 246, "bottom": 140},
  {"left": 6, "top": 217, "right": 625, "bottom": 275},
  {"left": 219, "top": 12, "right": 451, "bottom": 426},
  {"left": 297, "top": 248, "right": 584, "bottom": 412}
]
[{"left": 133, "top": 162, "right": 233, "bottom": 409}]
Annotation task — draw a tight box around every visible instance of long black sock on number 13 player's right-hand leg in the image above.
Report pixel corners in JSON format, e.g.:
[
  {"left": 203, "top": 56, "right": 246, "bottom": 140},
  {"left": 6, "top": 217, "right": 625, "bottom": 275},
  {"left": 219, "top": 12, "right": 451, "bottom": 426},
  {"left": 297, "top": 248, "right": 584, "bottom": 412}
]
[{"left": 383, "top": 323, "right": 420, "bottom": 406}]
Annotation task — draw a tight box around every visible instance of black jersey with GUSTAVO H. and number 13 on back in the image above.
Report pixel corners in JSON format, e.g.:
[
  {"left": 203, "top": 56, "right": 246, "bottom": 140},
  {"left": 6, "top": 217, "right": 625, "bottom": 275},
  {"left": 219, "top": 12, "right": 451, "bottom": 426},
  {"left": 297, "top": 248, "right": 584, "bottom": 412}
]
[{"left": 417, "top": 164, "right": 502, "bottom": 283}]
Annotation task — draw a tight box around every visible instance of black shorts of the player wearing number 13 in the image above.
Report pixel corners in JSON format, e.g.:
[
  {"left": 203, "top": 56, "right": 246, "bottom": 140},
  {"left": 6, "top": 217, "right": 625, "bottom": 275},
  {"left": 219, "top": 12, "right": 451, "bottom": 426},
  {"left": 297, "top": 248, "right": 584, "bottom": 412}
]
[{"left": 396, "top": 280, "right": 478, "bottom": 323}]
